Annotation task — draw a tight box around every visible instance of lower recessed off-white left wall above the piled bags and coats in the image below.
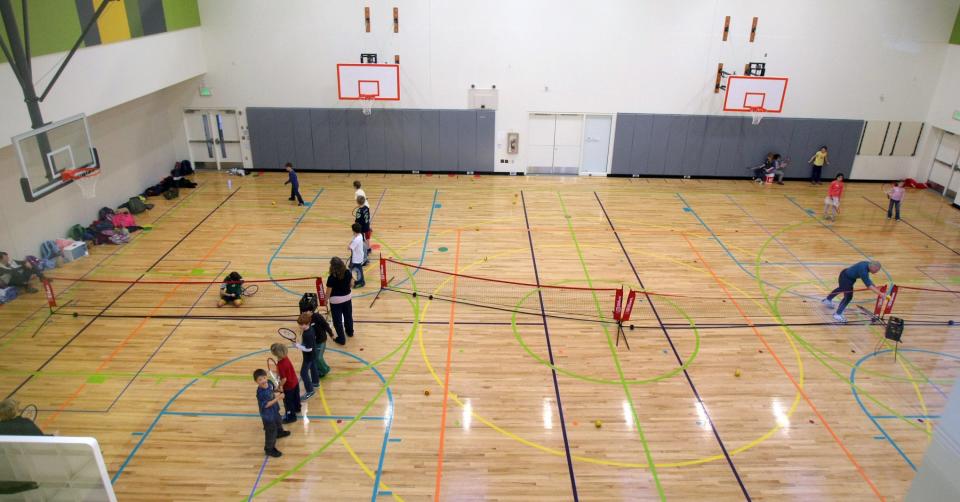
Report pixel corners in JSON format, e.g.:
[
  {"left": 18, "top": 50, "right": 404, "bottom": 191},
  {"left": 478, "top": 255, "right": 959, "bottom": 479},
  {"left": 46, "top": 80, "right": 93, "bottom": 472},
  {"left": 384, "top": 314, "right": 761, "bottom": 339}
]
[{"left": 0, "top": 79, "right": 200, "bottom": 258}]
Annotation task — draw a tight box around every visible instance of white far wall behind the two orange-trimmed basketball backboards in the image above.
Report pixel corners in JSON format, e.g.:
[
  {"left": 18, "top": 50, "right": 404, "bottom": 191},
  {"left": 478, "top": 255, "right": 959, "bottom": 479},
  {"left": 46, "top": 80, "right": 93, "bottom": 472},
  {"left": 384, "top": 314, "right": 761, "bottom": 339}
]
[{"left": 194, "top": 0, "right": 960, "bottom": 177}]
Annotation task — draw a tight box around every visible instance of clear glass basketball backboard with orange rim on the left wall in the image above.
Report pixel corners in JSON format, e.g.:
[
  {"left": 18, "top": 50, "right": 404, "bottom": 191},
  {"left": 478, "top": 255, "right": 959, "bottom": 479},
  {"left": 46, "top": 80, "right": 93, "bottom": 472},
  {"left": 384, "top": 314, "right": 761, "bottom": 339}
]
[{"left": 11, "top": 115, "right": 100, "bottom": 202}]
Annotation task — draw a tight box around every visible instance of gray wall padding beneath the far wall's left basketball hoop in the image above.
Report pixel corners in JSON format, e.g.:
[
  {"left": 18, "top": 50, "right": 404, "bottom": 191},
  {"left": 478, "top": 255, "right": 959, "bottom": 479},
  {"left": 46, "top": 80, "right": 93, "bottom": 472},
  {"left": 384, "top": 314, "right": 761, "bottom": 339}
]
[{"left": 247, "top": 108, "right": 496, "bottom": 172}]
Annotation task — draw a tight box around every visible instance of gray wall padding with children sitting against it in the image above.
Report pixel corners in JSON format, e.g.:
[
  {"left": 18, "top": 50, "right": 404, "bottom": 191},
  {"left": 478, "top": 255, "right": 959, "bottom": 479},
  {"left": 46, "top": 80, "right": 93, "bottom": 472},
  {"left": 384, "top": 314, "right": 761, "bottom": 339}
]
[{"left": 611, "top": 113, "right": 863, "bottom": 179}]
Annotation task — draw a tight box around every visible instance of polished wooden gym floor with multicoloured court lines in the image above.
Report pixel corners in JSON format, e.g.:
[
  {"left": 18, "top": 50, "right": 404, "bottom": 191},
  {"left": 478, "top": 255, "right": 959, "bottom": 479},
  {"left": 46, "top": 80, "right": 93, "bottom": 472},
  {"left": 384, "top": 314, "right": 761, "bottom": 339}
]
[{"left": 0, "top": 172, "right": 960, "bottom": 501}]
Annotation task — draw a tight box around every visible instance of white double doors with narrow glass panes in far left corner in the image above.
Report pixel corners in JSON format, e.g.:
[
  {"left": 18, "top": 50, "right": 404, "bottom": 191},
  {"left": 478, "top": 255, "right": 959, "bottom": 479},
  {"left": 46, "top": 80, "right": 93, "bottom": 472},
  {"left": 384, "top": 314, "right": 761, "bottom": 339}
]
[{"left": 183, "top": 110, "right": 243, "bottom": 169}]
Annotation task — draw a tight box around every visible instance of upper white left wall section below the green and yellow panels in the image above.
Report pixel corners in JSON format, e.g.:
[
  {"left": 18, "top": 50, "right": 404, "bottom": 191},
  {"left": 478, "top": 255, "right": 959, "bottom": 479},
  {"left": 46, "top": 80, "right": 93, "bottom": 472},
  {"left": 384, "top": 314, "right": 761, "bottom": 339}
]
[{"left": 0, "top": 28, "right": 206, "bottom": 149}]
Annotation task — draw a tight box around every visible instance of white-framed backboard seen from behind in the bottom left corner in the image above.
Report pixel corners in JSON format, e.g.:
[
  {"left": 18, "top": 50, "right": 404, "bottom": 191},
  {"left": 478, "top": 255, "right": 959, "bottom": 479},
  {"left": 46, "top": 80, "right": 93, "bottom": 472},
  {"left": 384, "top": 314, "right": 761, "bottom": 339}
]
[{"left": 0, "top": 436, "right": 117, "bottom": 502}]
